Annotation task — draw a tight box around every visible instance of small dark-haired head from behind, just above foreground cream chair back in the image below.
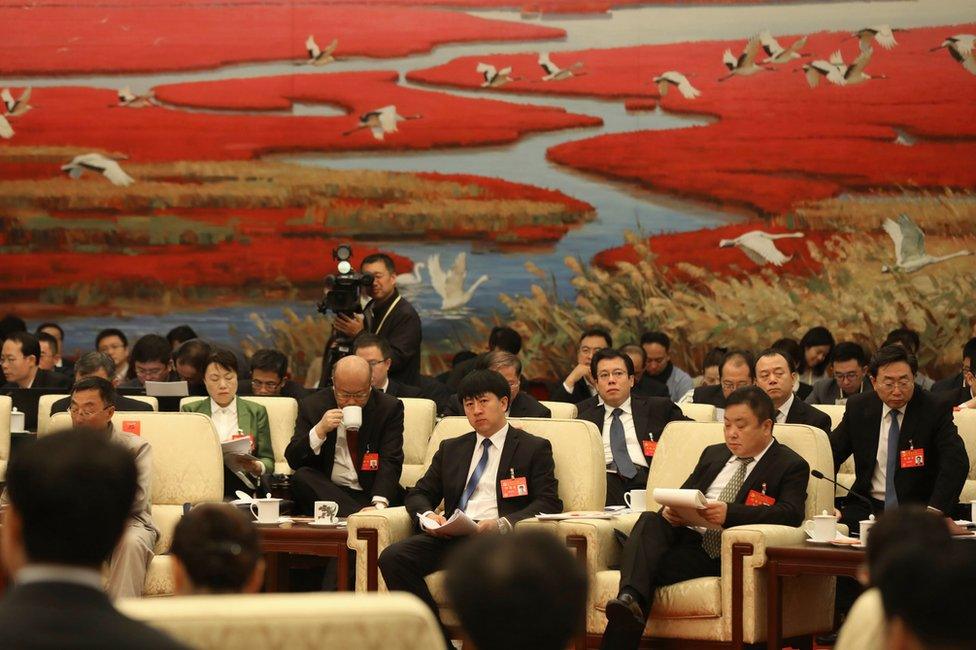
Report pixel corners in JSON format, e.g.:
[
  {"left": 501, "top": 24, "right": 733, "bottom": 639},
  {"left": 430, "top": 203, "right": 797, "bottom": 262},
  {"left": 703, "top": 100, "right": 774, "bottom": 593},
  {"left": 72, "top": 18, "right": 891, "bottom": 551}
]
[{"left": 170, "top": 503, "right": 264, "bottom": 596}]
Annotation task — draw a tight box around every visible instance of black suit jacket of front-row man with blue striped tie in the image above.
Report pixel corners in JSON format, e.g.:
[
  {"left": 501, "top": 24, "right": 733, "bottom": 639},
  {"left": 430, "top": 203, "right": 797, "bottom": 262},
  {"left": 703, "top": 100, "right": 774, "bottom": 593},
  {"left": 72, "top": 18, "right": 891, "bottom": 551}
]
[{"left": 404, "top": 426, "right": 563, "bottom": 530}]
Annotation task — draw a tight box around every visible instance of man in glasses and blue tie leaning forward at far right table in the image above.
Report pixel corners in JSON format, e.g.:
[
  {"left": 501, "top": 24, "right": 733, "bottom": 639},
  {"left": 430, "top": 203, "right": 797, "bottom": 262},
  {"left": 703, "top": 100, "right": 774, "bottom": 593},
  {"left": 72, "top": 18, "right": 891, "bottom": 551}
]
[{"left": 830, "top": 345, "right": 969, "bottom": 530}]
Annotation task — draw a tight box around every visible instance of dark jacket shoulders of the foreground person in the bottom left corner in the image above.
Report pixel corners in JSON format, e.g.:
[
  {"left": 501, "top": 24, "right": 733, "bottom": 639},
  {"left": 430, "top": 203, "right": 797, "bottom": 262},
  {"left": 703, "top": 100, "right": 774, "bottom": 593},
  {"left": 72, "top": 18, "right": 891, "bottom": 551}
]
[{"left": 0, "top": 582, "right": 185, "bottom": 650}]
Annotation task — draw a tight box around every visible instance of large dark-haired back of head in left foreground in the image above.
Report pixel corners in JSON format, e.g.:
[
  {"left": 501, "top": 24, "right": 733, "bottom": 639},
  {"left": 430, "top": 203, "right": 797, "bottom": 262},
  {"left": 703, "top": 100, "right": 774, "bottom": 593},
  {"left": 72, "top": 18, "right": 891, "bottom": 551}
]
[{"left": 4, "top": 429, "right": 137, "bottom": 569}]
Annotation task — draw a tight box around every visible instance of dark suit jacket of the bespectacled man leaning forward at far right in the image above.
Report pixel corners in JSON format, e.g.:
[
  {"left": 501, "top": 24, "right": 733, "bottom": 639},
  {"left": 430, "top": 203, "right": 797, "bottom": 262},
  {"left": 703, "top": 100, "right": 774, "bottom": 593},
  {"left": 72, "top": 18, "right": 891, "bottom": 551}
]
[{"left": 830, "top": 386, "right": 969, "bottom": 513}]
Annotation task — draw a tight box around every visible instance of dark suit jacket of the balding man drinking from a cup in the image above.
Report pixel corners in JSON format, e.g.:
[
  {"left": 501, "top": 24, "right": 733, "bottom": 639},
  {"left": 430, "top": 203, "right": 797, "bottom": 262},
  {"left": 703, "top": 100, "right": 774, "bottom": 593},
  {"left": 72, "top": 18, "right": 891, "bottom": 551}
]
[{"left": 285, "top": 388, "right": 403, "bottom": 503}]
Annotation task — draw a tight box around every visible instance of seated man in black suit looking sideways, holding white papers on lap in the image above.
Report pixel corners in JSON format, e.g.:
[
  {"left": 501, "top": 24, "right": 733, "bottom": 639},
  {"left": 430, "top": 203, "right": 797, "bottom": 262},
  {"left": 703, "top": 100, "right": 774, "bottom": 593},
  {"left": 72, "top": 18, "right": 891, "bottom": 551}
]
[{"left": 602, "top": 386, "right": 810, "bottom": 650}]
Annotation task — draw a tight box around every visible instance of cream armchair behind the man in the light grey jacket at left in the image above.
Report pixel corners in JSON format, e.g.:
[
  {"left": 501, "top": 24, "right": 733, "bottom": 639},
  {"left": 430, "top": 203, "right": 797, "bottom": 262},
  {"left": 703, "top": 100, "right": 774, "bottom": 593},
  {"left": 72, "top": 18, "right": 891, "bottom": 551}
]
[{"left": 49, "top": 412, "right": 224, "bottom": 596}]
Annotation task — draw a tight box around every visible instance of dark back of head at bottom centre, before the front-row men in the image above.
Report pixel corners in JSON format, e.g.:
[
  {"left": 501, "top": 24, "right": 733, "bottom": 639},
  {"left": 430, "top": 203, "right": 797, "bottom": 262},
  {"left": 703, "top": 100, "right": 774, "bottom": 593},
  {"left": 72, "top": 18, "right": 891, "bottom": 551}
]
[{"left": 445, "top": 531, "right": 587, "bottom": 650}]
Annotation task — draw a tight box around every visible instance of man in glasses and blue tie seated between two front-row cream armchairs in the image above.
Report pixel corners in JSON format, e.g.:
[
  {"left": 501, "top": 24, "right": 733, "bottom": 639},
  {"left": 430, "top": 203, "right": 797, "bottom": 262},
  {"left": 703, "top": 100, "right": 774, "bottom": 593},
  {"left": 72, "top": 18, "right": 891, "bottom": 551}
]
[{"left": 577, "top": 348, "right": 688, "bottom": 506}]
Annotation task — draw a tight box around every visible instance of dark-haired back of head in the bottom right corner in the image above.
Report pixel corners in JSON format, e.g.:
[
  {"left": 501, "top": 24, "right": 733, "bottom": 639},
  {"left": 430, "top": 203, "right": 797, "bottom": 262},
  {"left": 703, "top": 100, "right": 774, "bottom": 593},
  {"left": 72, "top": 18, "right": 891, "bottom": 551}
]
[{"left": 868, "top": 530, "right": 976, "bottom": 650}]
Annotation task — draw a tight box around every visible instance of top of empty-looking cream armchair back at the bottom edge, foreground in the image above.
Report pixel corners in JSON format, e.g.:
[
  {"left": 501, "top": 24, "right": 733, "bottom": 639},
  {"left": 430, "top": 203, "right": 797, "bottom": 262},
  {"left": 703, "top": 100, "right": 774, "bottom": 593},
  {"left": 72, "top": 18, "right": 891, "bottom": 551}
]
[{"left": 116, "top": 594, "right": 444, "bottom": 650}]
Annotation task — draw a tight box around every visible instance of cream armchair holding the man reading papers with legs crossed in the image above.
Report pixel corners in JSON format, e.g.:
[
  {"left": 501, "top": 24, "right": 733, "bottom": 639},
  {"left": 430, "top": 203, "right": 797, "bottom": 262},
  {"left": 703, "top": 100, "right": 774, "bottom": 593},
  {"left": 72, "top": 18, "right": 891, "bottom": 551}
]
[{"left": 559, "top": 422, "right": 834, "bottom": 647}]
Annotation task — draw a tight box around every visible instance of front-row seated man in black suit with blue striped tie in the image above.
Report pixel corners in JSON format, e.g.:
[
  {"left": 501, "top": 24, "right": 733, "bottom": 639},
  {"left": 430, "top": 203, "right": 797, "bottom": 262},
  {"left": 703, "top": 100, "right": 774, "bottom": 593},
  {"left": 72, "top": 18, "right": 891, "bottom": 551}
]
[{"left": 379, "top": 370, "right": 563, "bottom": 636}]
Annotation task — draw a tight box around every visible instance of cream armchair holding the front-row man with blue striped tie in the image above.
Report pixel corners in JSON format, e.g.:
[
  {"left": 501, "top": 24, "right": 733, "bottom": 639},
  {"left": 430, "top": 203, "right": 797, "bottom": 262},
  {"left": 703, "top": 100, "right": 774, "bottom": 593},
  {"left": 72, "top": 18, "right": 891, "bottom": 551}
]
[{"left": 349, "top": 417, "right": 607, "bottom": 604}]
